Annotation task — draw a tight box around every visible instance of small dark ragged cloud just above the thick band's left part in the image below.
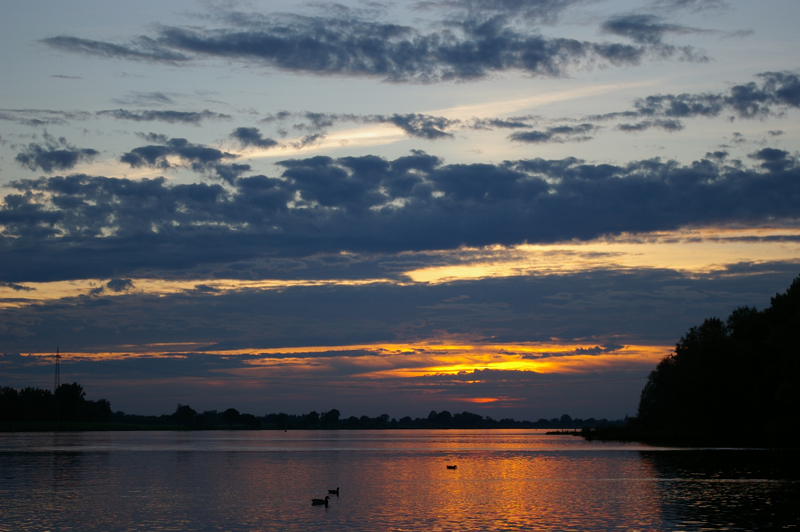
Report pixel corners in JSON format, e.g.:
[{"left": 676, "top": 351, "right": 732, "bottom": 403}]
[{"left": 120, "top": 134, "right": 238, "bottom": 172}]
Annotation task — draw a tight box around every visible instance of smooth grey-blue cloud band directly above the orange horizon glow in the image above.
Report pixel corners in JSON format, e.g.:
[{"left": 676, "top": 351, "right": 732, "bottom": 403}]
[{"left": 0, "top": 263, "right": 798, "bottom": 357}]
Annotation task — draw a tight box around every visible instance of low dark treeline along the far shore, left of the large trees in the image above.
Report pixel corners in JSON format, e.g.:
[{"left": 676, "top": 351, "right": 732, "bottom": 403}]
[{"left": 0, "top": 383, "right": 625, "bottom": 430}]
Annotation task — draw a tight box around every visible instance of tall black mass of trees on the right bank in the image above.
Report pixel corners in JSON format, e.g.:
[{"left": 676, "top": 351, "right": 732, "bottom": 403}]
[{"left": 584, "top": 277, "right": 800, "bottom": 447}]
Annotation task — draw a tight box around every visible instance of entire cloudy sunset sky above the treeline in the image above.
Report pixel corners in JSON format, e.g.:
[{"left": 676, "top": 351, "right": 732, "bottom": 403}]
[{"left": 0, "top": 0, "right": 800, "bottom": 420}]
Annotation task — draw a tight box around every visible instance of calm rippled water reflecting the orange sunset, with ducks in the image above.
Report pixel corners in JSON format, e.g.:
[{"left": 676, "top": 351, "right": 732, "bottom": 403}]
[{"left": 0, "top": 430, "right": 800, "bottom": 531}]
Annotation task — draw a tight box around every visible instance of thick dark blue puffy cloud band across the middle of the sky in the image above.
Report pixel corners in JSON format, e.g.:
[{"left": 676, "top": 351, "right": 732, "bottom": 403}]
[{"left": 0, "top": 149, "right": 800, "bottom": 283}]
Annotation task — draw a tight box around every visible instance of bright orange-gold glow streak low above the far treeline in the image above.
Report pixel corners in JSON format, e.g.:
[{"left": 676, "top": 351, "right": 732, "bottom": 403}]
[{"left": 20, "top": 342, "right": 671, "bottom": 382}]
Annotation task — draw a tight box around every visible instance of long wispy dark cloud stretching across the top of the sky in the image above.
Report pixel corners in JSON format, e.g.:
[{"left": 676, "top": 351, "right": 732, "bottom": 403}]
[{"left": 42, "top": 5, "right": 703, "bottom": 82}]
